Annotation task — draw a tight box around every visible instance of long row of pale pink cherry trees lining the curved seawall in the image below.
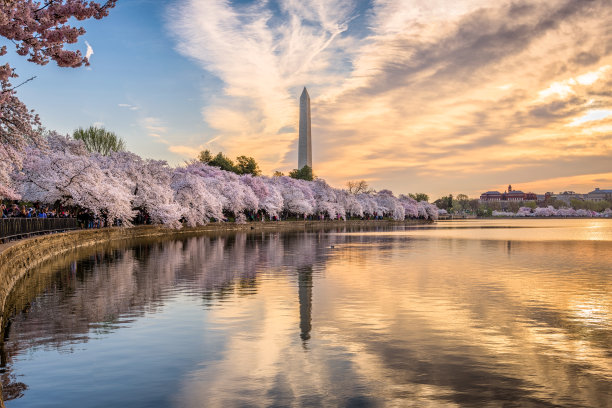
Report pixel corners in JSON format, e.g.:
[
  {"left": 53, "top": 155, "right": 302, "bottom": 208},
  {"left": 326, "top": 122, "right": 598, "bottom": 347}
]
[{"left": 11, "top": 133, "right": 438, "bottom": 228}]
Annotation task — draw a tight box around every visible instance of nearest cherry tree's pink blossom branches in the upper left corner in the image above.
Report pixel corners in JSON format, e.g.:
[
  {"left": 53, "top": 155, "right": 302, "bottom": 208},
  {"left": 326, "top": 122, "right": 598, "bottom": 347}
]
[{"left": 0, "top": 0, "right": 117, "bottom": 198}]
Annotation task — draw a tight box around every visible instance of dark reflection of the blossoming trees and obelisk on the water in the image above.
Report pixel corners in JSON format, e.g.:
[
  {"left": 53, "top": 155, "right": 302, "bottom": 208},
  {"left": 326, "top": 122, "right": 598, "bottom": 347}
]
[{"left": 0, "top": 228, "right": 356, "bottom": 400}]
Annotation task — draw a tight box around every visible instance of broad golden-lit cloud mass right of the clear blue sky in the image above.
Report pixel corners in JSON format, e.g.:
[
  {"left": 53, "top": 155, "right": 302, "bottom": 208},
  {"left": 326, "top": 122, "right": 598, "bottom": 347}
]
[{"left": 170, "top": 0, "right": 612, "bottom": 195}]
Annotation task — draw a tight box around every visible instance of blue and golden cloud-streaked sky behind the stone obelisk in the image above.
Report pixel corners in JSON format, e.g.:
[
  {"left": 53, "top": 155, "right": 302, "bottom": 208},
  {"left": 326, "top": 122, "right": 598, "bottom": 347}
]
[{"left": 5, "top": 0, "right": 612, "bottom": 199}]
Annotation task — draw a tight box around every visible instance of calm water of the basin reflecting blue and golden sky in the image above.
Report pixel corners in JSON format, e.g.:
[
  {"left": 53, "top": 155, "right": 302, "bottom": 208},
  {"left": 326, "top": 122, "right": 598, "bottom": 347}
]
[{"left": 1, "top": 219, "right": 612, "bottom": 408}]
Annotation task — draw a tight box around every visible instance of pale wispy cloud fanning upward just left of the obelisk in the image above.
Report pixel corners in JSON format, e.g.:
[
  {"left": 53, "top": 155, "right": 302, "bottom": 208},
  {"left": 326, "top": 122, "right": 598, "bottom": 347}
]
[{"left": 172, "top": 0, "right": 353, "bottom": 166}]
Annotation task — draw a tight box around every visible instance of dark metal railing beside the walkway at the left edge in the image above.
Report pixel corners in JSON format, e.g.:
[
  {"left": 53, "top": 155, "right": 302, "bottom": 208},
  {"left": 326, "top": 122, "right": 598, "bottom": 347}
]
[{"left": 0, "top": 218, "right": 79, "bottom": 241}]
